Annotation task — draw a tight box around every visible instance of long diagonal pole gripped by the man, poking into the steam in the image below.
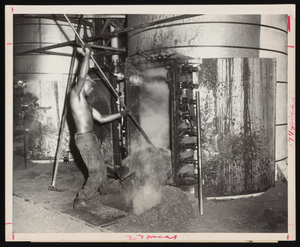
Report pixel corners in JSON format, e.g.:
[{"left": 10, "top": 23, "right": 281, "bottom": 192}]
[{"left": 63, "top": 14, "right": 155, "bottom": 148}]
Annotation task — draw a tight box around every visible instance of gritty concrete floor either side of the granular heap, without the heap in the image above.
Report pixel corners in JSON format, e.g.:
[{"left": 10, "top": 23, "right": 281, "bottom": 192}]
[{"left": 9, "top": 156, "right": 287, "bottom": 237}]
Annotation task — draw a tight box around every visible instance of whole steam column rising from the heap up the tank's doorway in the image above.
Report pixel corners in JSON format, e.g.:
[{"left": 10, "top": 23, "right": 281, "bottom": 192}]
[{"left": 123, "top": 68, "right": 171, "bottom": 215}]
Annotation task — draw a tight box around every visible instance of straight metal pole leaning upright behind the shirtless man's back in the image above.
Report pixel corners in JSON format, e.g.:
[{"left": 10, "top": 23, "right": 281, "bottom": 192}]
[{"left": 48, "top": 16, "right": 81, "bottom": 191}]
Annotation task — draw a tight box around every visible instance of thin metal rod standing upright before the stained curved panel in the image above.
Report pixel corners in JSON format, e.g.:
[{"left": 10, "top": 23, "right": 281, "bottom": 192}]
[{"left": 196, "top": 91, "right": 203, "bottom": 215}]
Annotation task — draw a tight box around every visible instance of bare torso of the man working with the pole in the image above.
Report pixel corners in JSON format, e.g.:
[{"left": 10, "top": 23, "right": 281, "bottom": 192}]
[{"left": 70, "top": 90, "right": 94, "bottom": 133}]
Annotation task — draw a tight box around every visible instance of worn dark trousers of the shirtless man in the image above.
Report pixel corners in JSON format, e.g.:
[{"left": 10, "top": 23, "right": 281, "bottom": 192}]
[{"left": 75, "top": 131, "right": 108, "bottom": 200}]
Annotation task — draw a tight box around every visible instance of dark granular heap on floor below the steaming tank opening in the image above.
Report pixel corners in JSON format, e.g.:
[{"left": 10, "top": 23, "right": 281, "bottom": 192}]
[{"left": 107, "top": 186, "right": 193, "bottom": 232}]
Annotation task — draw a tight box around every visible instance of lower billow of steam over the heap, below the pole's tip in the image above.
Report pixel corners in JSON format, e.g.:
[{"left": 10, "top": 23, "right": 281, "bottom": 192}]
[{"left": 122, "top": 147, "right": 171, "bottom": 215}]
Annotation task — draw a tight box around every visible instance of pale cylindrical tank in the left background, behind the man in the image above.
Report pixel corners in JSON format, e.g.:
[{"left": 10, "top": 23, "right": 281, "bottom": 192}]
[{"left": 13, "top": 16, "right": 90, "bottom": 160}]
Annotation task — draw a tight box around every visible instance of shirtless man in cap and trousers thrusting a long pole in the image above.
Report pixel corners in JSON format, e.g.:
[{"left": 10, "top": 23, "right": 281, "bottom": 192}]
[{"left": 70, "top": 46, "right": 130, "bottom": 209}]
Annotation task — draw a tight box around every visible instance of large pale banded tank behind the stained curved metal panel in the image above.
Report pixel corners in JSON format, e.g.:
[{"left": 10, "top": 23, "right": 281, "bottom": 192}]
[{"left": 127, "top": 14, "right": 288, "bottom": 197}]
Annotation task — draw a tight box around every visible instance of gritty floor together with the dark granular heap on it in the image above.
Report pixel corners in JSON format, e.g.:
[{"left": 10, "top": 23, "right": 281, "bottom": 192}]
[{"left": 12, "top": 156, "right": 288, "bottom": 233}]
